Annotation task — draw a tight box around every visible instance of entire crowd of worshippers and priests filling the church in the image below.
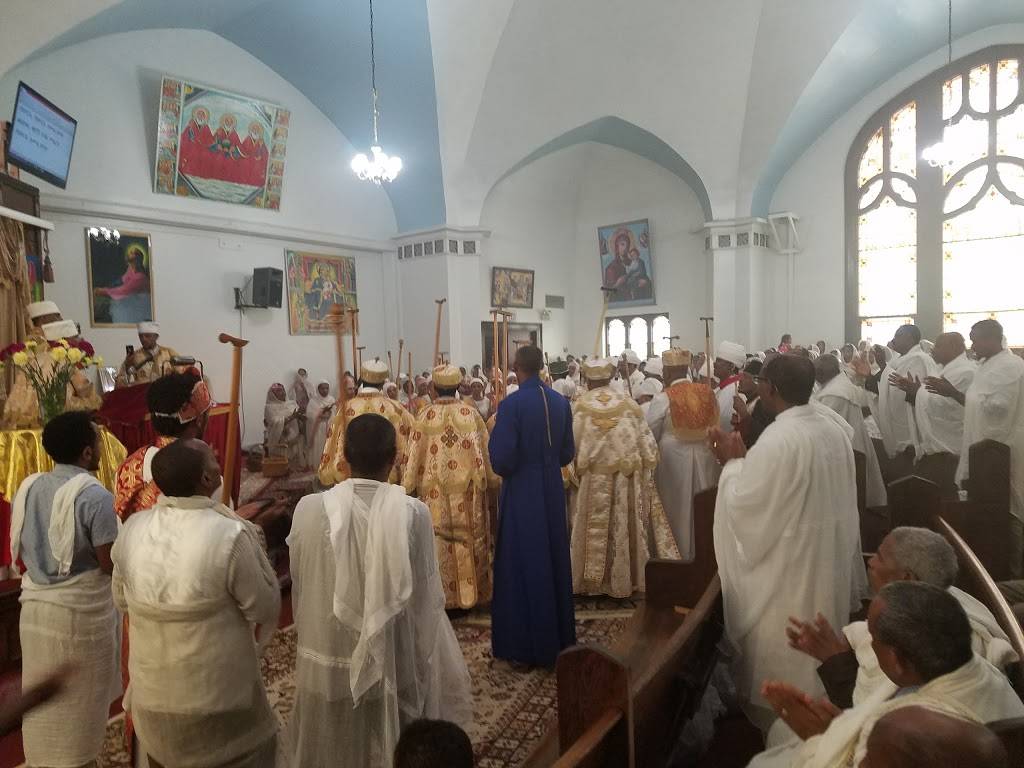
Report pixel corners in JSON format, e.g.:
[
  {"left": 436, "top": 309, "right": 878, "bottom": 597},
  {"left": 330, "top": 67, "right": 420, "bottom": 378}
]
[{"left": 4, "top": 301, "right": 1024, "bottom": 767}]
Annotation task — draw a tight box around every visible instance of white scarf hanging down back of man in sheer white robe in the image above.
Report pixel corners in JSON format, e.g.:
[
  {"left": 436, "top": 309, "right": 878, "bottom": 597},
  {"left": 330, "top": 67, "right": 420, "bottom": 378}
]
[{"left": 324, "top": 480, "right": 413, "bottom": 705}]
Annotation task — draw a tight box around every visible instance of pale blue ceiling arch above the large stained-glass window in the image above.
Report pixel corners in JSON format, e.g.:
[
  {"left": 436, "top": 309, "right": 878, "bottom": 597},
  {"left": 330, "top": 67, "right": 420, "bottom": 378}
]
[{"left": 751, "top": 0, "right": 1024, "bottom": 216}]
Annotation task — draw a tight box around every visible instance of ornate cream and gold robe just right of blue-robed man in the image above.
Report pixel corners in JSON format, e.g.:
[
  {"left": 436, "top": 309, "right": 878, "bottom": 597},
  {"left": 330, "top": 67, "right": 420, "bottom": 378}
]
[{"left": 569, "top": 387, "right": 679, "bottom": 597}]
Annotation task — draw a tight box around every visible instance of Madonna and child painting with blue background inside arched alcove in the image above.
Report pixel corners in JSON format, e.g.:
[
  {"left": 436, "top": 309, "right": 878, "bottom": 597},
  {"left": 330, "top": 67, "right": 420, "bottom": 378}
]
[{"left": 597, "top": 219, "right": 655, "bottom": 307}]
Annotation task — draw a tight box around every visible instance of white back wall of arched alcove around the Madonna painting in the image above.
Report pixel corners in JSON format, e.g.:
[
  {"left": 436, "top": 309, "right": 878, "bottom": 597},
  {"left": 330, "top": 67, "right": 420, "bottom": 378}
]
[{"left": 474, "top": 143, "right": 711, "bottom": 361}]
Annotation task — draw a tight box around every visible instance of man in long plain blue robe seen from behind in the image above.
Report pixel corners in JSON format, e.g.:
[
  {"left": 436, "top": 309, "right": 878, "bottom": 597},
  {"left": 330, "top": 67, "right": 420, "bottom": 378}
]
[{"left": 489, "top": 346, "right": 575, "bottom": 667}]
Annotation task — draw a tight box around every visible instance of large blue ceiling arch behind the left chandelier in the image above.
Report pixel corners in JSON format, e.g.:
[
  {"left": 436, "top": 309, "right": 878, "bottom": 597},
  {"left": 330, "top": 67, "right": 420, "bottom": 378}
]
[{"left": 22, "top": 0, "right": 445, "bottom": 231}]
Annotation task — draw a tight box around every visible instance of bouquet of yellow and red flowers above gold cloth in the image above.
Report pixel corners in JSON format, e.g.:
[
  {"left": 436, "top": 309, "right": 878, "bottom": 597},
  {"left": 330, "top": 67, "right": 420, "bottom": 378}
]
[{"left": 0, "top": 339, "right": 103, "bottom": 424}]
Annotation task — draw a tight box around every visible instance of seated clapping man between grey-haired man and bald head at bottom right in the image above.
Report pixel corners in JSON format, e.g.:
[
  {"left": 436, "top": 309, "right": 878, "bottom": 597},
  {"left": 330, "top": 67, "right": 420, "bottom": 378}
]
[{"left": 749, "top": 582, "right": 1024, "bottom": 768}]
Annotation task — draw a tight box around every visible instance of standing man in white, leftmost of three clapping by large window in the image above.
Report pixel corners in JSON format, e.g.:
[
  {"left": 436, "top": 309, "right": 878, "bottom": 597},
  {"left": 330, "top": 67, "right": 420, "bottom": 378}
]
[{"left": 878, "top": 326, "right": 935, "bottom": 482}]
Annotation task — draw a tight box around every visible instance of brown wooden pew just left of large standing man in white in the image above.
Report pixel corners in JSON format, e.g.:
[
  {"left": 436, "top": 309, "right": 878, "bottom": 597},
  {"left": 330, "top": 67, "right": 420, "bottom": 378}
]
[{"left": 525, "top": 488, "right": 723, "bottom": 768}]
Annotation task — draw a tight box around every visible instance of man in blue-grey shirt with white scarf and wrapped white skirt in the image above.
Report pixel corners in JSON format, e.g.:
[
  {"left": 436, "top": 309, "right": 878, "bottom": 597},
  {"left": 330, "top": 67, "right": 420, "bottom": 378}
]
[{"left": 10, "top": 412, "right": 121, "bottom": 766}]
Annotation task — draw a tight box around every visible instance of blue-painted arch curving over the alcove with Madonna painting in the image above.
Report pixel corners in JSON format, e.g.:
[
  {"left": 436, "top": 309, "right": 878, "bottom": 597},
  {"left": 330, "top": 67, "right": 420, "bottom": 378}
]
[{"left": 492, "top": 116, "right": 713, "bottom": 221}]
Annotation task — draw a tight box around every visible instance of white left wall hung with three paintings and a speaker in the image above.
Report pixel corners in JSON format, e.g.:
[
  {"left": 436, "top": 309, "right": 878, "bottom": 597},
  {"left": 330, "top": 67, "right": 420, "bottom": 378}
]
[{"left": 0, "top": 30, "right": 398, "bottom": 442}]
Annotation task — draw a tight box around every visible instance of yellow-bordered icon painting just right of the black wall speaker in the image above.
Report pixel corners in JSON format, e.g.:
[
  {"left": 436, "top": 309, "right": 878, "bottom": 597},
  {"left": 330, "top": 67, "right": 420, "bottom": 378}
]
[{"left": 285, "top": 250, "right": 358, "bottom": 336}]
